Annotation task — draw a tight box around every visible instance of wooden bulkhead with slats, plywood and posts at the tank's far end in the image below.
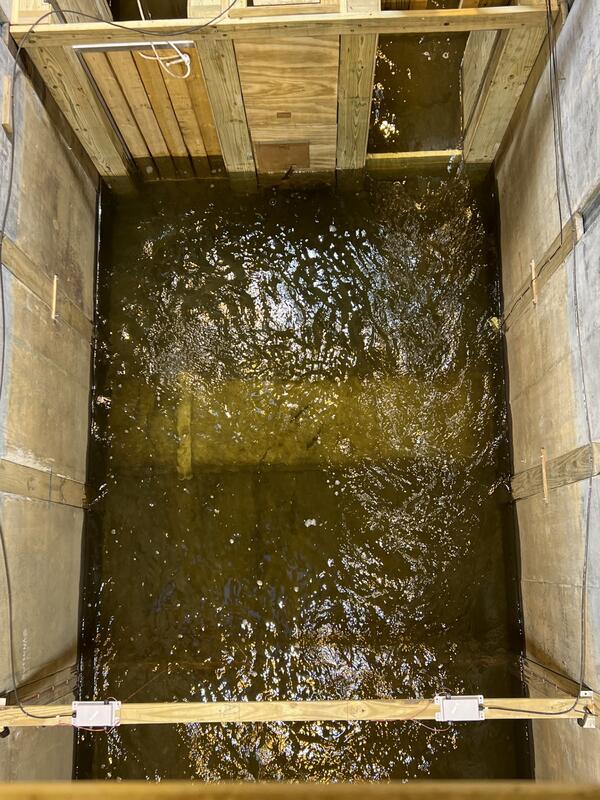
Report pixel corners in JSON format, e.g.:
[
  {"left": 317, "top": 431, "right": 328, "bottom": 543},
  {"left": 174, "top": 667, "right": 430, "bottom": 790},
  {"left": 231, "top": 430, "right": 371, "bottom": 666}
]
[{"left": 10, "top": 0, "right": 546, "bottom": 179}]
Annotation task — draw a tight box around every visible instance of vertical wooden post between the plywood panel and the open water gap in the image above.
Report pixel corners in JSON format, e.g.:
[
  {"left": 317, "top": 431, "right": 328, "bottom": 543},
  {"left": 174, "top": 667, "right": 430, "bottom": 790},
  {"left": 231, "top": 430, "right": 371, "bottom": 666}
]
[{"left": 336, "top": 34, "right": 379, "bottom": 169}]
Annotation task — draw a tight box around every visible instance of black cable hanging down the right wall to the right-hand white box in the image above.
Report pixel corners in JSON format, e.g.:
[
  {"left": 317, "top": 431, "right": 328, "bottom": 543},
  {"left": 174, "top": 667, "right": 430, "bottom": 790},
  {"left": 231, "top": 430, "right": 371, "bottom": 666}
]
[{"left": 486, "top": 0, "right": 593, "bottom": 717}]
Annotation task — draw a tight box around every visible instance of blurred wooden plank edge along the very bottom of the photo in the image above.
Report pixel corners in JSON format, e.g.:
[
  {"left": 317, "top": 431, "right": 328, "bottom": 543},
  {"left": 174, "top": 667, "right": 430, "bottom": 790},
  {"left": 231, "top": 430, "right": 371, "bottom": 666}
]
[{"left": 0, "top": 779, "right": 600, "bottom": 800}]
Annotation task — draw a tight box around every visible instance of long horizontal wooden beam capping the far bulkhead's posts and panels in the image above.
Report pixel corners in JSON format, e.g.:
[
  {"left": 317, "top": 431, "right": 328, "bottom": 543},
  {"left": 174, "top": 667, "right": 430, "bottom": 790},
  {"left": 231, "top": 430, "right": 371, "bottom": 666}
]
[{"left": 10, "top": 5, "right": 546, "bottom": 50}]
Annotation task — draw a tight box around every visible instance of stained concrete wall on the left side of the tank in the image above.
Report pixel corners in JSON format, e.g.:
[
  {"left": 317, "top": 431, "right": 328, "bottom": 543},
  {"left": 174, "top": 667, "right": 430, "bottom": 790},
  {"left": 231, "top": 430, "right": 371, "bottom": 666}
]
[{"left": 0, "top": 18, "right": 97, "bottom": 780}]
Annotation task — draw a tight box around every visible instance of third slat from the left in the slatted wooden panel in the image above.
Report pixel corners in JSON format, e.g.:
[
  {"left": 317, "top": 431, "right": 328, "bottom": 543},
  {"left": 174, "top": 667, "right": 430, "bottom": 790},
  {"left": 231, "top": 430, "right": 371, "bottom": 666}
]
[{"left": 133, "top": 50, "right": 193, "bottom": 178}]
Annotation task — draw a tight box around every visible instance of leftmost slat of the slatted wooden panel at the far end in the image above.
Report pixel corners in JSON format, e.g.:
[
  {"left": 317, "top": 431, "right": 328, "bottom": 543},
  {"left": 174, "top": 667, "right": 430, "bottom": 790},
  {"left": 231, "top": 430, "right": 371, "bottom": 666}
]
[{"left": 84, "top": 52, "right": 156, "bottom": 173}]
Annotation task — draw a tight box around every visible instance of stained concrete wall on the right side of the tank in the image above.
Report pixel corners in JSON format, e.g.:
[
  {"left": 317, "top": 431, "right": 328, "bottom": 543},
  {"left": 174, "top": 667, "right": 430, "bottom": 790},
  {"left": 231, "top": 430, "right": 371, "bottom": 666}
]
[{"left": 496, "top": 0, "right": 600, "bottom": 782}]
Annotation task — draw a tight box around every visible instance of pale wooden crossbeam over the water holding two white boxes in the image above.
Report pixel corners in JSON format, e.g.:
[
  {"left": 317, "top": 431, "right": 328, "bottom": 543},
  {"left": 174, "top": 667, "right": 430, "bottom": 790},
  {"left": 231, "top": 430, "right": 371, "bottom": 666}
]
[{"left": 0, "top": 696, "right": 596, "bottom": 728}]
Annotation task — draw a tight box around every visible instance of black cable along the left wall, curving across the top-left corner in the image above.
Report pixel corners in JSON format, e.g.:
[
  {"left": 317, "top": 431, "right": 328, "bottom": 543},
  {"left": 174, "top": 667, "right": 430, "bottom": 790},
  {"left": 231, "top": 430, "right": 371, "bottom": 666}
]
[{"left": 0, "top": 0, "right": 238, "bottom": 719}]
